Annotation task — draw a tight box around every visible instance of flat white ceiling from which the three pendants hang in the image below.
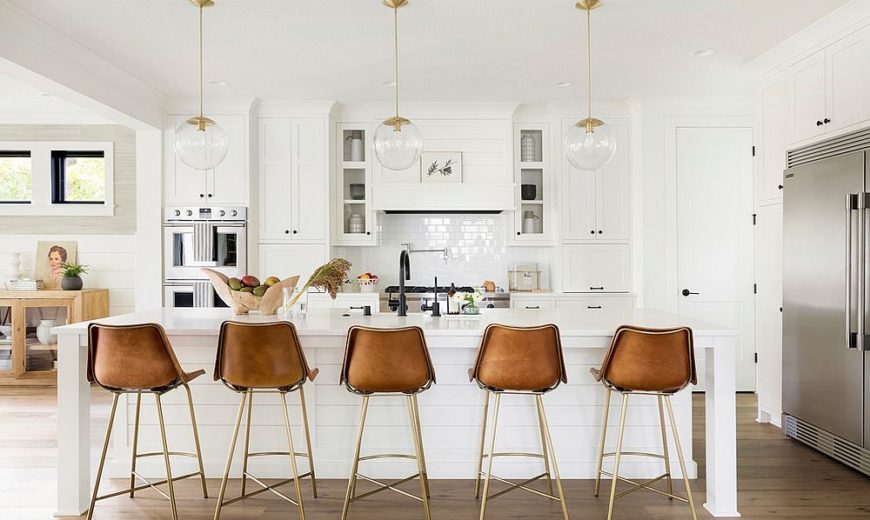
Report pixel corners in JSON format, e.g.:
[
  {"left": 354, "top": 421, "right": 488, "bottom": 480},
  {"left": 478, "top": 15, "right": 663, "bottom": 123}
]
[{"left": 0, "top": 0, "right": 847, "bottom": 103}]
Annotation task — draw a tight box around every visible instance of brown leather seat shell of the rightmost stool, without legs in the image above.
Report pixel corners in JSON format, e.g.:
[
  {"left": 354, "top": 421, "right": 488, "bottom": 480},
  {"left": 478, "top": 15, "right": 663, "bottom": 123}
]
[{"left": 599, "top": 325, "right": 698, "bottom": 393}]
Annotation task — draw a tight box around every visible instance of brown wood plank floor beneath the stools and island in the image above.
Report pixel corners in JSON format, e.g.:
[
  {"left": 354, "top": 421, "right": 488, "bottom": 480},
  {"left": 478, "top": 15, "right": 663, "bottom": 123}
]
[{"left": 0, "top": 388, "right": 870, "bottom": 520}]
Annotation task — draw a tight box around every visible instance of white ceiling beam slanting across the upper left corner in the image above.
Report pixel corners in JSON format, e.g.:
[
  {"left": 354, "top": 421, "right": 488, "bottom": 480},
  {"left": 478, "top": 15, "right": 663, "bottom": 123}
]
[{"left": 0, "top": 0, "right": 163, "bottom": 129}]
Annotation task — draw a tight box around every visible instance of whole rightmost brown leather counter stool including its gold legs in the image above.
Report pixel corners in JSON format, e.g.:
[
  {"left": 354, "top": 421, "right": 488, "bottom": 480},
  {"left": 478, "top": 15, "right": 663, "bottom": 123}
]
[{"left": 591, "top": 326, "right": 698, "bottom": 520}]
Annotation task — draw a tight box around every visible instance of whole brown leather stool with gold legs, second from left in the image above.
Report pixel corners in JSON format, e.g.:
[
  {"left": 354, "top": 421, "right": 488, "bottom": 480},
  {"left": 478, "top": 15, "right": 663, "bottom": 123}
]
[{"left": 214, "top": 321, "right": 318, "bottom": 520}]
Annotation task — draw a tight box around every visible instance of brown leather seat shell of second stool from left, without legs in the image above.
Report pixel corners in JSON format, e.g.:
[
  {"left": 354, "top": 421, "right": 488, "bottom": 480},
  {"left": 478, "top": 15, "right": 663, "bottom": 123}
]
[{"left": 214, "top": 321, "right": 309, "bottom": 391}]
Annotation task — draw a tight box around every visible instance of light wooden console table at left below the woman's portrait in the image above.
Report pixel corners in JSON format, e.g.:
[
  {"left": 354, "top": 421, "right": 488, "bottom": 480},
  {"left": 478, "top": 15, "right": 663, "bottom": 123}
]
[{"left": 0, "top": 289, "right": 109, "bottom": 385}]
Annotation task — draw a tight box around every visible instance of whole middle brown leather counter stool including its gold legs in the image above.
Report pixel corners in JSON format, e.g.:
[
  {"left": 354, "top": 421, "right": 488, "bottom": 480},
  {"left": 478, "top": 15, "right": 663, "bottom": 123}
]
[{"left": 340, "top": 326, "right": 435, "bottom": 520}]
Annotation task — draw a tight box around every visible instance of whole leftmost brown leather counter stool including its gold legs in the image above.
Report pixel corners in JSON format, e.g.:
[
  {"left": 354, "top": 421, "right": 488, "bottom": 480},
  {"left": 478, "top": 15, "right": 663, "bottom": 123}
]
[{"left": 87, "top": 323, "right": 208, "bottom": 520}]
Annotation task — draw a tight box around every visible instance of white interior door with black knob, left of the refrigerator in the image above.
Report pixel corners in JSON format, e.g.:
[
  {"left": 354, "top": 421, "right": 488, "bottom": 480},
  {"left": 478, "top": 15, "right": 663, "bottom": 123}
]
[{"left": 676, "top": 127, "right": 755, "bottom": 391}]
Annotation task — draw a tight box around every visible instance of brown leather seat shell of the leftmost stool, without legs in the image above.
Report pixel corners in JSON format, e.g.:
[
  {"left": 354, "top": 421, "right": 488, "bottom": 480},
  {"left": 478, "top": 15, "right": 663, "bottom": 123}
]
[{"left": 87, "top": 323, "right": 184, "bottom": 392}]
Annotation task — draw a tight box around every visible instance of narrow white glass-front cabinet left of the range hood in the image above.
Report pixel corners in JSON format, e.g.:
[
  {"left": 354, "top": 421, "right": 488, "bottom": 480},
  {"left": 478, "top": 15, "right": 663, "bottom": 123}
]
[{"left": 332, "top": 123, "right": 377, "bottom": 246}]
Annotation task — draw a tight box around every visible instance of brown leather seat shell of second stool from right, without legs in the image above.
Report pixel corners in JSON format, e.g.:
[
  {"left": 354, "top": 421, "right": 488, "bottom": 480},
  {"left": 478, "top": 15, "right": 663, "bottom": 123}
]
[{"left": 471, "top": 323, "right": 568, "bottom": 392}]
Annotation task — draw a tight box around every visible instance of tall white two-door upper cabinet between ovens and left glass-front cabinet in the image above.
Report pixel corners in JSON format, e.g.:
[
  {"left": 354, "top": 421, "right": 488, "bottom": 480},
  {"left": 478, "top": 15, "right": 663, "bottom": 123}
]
[{"left": 258, "top": 118, "right": 328, "bottom": 242}]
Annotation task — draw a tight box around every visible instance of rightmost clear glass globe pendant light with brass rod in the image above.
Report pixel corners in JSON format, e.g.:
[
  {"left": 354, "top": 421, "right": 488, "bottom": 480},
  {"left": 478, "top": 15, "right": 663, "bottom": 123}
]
[{"left": 564, "top": 0, "right": 616, "bottom": 170}]
